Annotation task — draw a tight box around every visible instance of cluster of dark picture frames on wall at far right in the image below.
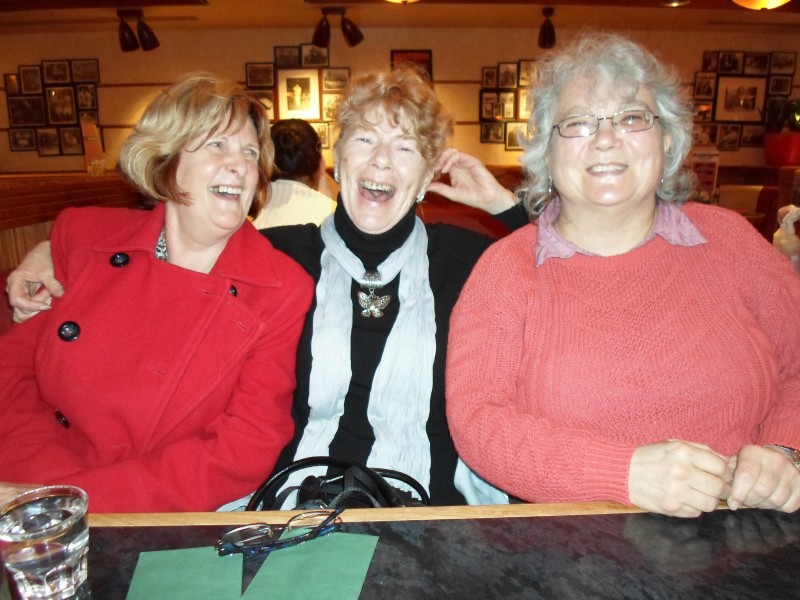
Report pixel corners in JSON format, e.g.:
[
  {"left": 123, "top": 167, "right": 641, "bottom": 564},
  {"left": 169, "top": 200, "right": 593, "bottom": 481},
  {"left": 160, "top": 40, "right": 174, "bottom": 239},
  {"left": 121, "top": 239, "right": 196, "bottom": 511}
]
[{"left": 692, "top": 50, "right": 797, "bottom": 151}]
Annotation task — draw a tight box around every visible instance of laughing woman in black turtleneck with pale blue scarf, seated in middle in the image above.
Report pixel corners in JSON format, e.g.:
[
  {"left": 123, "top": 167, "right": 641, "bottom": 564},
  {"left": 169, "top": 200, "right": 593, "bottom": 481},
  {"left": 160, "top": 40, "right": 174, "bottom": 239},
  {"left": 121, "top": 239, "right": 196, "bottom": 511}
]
[{"left": 9, "top": 68, "right": 528, "bottom": 508}]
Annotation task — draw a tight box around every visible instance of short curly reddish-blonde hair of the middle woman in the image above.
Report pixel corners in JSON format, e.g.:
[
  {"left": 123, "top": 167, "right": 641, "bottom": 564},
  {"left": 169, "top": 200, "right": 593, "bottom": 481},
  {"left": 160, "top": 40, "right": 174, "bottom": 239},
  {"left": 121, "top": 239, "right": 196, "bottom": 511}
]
[{"left": 334, "top": 67, "right": 453, "bottom": 167}]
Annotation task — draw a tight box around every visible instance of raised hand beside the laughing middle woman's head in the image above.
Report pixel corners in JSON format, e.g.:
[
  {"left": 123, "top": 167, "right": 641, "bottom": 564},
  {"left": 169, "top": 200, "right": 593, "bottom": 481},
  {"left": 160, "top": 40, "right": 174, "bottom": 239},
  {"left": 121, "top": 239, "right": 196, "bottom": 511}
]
[{"left": 428, "top": 148, "right": 516, "bottom": 215}]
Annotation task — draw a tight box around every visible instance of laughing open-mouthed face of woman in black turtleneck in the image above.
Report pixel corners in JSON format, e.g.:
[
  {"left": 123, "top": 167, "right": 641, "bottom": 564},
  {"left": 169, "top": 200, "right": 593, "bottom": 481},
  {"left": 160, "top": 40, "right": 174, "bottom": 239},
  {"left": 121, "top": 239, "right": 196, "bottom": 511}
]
[{"left": 336, "top": 108, "right": 433, "bottom": 234}]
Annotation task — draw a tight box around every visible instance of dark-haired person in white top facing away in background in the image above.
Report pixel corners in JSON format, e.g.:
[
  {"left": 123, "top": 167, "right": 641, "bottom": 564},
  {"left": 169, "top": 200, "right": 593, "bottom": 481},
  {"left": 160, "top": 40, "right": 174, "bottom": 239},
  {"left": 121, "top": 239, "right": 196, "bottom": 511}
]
[{"left": 253, "top": 119, "right": 336, "bottom": 229}]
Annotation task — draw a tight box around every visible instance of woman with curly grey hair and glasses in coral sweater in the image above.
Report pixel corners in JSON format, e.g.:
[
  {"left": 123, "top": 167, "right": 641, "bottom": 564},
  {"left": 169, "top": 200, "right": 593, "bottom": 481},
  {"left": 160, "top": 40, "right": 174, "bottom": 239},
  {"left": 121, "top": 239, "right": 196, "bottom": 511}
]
[{"left": 447, "top": 34, "right": 800, "bottom": 517}]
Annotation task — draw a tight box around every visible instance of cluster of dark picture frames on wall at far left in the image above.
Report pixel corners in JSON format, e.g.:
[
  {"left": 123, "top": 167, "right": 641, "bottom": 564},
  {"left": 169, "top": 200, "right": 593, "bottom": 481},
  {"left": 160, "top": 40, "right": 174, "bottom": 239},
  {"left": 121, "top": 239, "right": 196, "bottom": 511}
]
[{"left": 3, "top": 58, "right": 100, "bottom": 156}]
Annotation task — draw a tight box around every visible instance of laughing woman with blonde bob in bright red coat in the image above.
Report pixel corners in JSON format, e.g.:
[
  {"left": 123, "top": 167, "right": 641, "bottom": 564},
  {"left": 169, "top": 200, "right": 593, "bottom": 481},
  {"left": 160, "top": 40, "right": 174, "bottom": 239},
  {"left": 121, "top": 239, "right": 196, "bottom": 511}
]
[{"left": 0, "top": 73, "right": 313, "bottom": 512}]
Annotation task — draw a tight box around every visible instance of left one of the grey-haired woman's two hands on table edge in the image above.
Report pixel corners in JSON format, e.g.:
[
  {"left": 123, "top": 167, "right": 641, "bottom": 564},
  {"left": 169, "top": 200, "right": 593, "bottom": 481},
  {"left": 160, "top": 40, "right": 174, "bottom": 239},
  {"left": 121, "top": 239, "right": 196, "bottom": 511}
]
[{"left": 628, "top": 440, "right": 733, "bottom": 517}]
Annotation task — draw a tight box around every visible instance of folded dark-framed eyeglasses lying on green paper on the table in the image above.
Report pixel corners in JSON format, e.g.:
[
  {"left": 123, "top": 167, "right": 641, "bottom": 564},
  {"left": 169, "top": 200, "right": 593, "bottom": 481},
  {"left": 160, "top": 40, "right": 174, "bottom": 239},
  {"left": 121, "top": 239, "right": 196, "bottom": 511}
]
[{"left": 214, "top": 506, "right": 344, "bottom": 556}]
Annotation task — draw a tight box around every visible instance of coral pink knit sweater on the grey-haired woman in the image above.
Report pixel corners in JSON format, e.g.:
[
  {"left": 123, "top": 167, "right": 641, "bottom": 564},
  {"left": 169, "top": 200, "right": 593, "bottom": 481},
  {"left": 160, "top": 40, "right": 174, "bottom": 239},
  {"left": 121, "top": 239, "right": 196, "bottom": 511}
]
[{"left": 447, "top": 204, "right": 800, "bottom": 503}]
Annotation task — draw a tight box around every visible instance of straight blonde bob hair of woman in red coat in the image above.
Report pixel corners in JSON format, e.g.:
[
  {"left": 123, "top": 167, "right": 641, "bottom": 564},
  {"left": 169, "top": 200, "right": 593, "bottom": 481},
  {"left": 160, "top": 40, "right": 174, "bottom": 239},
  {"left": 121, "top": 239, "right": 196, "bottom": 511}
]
[{"left": 119, "top": 73, "right": 275, "bottom": 217}]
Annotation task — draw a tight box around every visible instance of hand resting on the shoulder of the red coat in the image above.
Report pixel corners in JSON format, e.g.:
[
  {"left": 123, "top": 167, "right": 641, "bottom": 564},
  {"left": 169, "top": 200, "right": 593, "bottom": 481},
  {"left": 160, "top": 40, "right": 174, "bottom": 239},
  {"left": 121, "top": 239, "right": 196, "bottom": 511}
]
[{"left": 6, "top": 242, "right": 64, "bottom": 323}]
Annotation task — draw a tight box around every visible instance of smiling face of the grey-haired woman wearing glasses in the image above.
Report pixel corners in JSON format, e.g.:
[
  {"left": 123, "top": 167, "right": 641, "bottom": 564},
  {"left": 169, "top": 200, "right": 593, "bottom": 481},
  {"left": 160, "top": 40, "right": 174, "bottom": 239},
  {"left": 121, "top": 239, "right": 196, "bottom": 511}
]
[{"left": 547, "top": 80, "right": 668, "bottom": 219}]
